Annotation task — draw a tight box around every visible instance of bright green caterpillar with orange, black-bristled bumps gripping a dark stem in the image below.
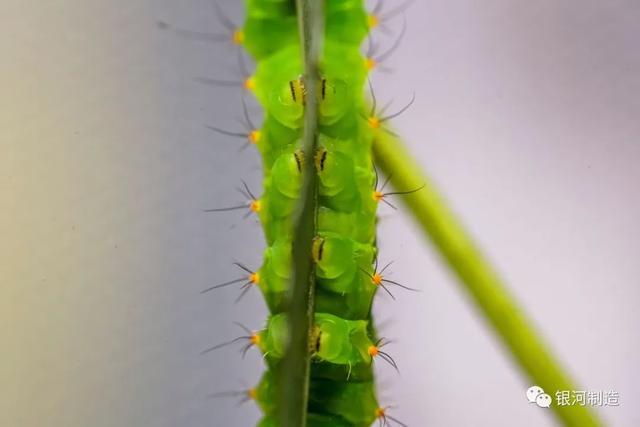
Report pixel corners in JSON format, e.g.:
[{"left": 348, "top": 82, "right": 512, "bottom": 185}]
[{"left": 205, "top": 0, "right": 416, "bottom": 427}]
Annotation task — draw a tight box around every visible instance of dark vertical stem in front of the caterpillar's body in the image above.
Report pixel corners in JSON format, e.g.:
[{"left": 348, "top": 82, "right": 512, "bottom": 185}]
[{"left": 279, "top": 0, "right": 323, "bottom": 427}]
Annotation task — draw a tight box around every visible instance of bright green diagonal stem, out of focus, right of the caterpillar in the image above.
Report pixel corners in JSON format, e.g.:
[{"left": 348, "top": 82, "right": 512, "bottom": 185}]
[{"left": 374, "top": 132, "right": 603, "bottom": 427}]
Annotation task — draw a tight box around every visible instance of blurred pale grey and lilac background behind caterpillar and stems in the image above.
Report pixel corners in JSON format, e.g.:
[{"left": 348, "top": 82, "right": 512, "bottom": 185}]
[{"left": 0, "top": 0, "right": 640, "bottom": 427}]
